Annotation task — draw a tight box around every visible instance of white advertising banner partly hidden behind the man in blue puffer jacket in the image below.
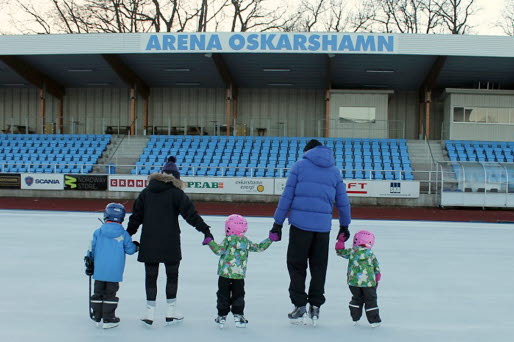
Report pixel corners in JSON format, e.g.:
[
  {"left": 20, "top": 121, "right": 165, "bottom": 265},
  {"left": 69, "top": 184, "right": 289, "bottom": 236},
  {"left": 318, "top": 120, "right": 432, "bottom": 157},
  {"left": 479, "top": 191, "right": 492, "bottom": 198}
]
[{"left": 275, "top": 178, "right": 419, "bottom": 198}]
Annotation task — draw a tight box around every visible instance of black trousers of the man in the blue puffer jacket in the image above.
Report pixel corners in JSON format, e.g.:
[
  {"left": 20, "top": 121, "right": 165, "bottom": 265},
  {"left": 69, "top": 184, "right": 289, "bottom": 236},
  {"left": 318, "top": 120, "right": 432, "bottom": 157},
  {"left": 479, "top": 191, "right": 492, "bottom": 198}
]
[{"left": 287, "top": 226, "right": 330, "bottom": 307}]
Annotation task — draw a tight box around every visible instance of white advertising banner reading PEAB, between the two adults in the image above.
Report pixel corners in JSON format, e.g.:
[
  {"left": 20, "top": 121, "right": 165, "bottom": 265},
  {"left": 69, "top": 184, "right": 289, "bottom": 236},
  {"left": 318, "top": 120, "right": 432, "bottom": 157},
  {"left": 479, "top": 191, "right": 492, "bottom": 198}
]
[{"left": 181, "top": 177, "right": 274, "bottom": 195}]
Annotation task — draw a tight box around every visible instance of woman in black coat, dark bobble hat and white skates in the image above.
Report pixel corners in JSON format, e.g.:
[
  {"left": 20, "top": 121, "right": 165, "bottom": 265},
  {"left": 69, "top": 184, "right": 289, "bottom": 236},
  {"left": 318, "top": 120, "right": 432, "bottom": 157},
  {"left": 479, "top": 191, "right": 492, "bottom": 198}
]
[{"left": 127, "top": 157, "right": 212, "bottom": 325}]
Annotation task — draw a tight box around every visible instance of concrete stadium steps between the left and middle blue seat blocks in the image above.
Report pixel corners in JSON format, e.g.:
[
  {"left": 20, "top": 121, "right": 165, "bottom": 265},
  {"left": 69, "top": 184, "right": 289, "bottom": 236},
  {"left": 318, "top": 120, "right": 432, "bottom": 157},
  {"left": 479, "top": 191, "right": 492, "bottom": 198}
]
[{"left": 103, "top": 136, "right": 149, "bottom": 174}]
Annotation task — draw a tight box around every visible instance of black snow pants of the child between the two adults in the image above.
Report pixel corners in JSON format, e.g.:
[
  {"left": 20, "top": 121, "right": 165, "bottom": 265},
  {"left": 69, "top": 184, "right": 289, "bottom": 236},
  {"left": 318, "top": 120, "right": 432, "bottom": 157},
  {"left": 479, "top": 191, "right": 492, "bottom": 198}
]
[{"left": 216, "top": 277, "right": 245, "bottom": 316}]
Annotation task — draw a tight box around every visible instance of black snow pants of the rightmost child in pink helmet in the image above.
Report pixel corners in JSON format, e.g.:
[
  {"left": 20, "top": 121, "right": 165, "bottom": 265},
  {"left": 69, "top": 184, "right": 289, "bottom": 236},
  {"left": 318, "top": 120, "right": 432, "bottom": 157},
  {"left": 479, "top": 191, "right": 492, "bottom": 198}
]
[{"left": 350, "top": 285, "right": 382, "bottom": 323}]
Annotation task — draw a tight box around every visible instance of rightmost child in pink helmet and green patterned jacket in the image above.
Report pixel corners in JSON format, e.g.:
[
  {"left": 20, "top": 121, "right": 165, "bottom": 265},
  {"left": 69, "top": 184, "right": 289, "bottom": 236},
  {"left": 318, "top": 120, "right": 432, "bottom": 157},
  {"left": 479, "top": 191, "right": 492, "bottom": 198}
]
[{"left": 336, "top": 230, "right": 382, "bottom": 328}]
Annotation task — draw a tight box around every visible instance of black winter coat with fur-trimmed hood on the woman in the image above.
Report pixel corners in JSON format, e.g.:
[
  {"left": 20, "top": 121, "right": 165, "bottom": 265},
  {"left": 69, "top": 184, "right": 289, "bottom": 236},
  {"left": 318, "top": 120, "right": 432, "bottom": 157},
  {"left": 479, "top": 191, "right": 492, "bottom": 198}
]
[{"left": 127, "top": 173, "right": 210, "bottom": 263}]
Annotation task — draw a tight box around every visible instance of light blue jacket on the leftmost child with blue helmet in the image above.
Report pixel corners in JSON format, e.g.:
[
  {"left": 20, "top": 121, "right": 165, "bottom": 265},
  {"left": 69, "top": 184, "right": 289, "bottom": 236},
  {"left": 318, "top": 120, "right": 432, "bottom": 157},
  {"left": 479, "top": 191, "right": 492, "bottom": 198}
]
[{"left": 91, "top": 222, "right": 136, "bottom": 282}]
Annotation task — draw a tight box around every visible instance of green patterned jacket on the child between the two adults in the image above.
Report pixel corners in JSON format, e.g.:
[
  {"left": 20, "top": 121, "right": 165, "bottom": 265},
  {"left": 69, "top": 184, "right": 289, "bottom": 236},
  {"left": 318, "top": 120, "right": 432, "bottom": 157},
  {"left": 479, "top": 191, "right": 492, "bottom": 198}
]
[{"left": 209, "top": 235, "right": 271, "bottom": 279}]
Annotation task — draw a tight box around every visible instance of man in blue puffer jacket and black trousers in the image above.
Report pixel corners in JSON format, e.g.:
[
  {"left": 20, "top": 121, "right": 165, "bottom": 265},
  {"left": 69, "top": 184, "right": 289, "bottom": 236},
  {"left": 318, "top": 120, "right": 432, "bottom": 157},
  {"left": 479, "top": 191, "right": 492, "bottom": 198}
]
[{"left": 270, "top": 139, "right": 351, "bottom": 323}]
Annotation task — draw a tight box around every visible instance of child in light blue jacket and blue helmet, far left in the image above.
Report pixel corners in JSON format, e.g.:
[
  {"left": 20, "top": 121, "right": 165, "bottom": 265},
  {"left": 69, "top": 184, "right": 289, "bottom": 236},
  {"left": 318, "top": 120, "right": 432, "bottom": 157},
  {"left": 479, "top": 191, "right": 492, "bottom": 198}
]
[{"left": 87, "top": 203, "right": 139, "bottom": 329}]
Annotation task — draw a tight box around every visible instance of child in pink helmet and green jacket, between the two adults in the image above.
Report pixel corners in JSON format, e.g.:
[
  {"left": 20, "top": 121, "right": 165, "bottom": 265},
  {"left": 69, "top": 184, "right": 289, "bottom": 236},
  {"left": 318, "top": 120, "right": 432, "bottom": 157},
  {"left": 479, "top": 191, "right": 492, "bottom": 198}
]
[{"left": 203, "top": 214, "right": 271, "bottom": 328}]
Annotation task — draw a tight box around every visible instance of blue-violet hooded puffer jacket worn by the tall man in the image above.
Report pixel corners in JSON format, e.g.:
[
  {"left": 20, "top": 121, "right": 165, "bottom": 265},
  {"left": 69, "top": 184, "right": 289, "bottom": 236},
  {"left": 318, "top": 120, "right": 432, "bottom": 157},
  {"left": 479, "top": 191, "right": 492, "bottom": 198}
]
[{"left": 274, "top": 146, "right": 351, "bottom": 232}]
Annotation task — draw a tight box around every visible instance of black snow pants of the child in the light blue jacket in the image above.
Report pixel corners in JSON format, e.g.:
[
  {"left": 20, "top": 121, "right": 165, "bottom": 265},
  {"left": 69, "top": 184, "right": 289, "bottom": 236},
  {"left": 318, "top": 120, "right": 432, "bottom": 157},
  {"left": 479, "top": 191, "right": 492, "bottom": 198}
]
[{"left": 91, "top": 280, "right": 120, "bottom": 323}]
